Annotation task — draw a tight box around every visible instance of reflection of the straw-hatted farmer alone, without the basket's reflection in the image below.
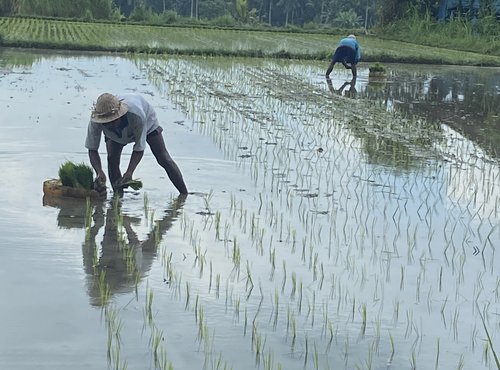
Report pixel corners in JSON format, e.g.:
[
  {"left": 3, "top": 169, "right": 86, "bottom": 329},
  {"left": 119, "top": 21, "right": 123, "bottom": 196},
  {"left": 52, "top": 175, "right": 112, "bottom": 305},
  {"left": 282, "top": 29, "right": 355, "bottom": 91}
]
[{"left": 82, "top": 195, "right": 186, "bottom": 306}]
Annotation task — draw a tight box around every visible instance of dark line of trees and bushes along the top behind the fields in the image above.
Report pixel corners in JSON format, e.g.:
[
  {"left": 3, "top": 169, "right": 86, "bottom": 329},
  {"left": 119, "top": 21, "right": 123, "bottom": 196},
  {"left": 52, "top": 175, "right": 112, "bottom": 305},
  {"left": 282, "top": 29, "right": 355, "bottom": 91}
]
[{"left": 0, "top": 0, "right": 500, "bottom": 29}]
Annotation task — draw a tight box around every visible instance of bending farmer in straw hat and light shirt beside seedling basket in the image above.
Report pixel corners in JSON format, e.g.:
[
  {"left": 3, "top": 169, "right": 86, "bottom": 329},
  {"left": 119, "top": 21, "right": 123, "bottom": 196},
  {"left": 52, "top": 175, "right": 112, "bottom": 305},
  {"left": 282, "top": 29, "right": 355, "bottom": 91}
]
[{"left": 85, "top": 93, "right": 188, "bottom": 194}]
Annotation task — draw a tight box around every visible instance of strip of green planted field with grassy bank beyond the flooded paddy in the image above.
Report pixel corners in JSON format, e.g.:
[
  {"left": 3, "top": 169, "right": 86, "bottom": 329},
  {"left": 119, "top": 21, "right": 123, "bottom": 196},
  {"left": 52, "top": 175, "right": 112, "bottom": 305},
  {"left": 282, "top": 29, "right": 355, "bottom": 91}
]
[{"left": 0, "top": 17, "right": 500, "bottom": 66}]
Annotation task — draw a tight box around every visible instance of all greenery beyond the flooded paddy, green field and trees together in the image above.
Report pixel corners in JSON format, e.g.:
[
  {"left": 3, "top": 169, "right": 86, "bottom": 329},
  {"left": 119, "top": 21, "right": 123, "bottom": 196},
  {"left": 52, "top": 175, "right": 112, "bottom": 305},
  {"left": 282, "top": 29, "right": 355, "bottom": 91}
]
[{"left": 0, "top": 0, "right": 500, "bottom": 65}]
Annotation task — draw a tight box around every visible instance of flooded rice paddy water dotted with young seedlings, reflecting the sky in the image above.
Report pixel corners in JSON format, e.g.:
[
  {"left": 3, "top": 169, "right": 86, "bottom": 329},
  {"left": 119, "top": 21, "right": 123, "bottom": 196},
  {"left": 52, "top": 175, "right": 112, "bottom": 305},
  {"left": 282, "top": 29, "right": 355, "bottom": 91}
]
[{"left": 0, "top": 50, "right": 500, "bottom": 370}]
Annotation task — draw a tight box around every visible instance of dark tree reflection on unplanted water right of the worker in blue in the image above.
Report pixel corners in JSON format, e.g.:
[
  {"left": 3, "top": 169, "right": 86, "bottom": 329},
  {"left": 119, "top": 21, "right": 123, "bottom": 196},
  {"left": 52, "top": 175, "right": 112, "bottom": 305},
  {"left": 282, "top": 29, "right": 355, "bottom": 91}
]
[{"left": 359, "top": 65, "right": 500, "bottom": 158}]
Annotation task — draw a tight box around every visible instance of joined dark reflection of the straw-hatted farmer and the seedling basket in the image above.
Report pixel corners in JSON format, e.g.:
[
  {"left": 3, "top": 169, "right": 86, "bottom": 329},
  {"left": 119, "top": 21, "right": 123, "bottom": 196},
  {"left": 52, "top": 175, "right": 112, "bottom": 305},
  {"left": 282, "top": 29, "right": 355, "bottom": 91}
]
[{"left": 43, "top": 195, "right": 186, "bottom": 306}]
